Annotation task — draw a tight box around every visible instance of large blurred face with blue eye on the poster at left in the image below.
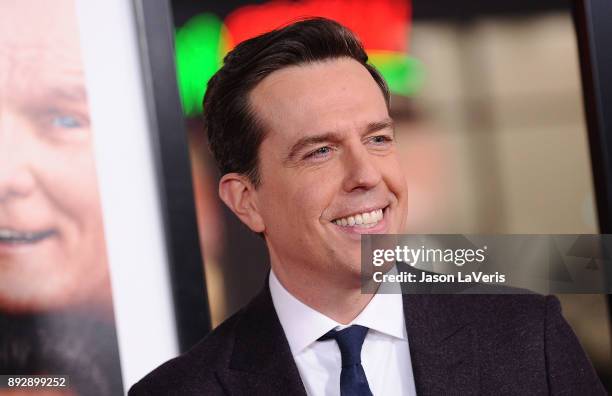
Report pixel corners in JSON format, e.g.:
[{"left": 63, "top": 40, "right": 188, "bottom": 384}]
[{"left": 0, "top": 1, "right": 108, "bottom": 310}]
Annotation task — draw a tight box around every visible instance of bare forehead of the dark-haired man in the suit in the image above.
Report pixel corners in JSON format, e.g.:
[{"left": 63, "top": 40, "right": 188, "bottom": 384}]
[{"left": 249, "top": 58, "right": 388, "bottom": 140}]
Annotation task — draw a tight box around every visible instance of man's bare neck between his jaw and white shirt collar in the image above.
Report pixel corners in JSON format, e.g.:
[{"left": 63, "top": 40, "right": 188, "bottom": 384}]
[{"left": 272, "top": 265, "right": 374, "bottom": 324}]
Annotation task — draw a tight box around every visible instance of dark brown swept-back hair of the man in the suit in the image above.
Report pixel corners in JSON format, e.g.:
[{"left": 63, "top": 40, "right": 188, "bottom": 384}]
[{"left": 204, "top": 18, "right": 389, "bottom": 187}]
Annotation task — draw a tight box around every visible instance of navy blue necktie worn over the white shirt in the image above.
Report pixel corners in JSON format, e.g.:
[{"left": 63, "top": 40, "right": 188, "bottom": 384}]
[{"left": 319, "top": 325, "right": 372, "bottom": 396}]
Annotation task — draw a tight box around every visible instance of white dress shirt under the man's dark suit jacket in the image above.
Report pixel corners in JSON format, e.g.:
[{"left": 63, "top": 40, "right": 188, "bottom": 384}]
[{"left": 270, "top": 271, "right": 416, "bottom": 396}]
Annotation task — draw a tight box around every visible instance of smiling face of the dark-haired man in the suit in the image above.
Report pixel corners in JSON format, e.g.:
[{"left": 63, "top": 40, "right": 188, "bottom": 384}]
[{"left": 250, "top": 58, "right": 407, "bottom": 284}]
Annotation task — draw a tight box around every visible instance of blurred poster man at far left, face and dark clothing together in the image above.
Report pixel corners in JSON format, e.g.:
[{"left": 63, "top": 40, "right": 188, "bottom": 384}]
[{"left": 0, "top": 0, "right": 121, "bottom": 394}]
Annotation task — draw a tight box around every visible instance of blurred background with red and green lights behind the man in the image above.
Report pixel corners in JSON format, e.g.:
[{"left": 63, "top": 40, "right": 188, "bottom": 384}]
[{"left": 172, "top": 0, "right": 612, "bottom": 389}]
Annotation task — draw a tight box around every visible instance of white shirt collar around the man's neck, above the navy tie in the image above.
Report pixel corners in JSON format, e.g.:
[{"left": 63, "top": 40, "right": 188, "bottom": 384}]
[{"left": 269, "top": 271, "right": 407, "bottom": 356}]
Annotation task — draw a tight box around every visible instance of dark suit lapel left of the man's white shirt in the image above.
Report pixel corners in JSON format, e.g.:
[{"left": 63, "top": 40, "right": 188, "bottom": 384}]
[{"left": 218, "top": 282, "right": 306, "bottom": 396}]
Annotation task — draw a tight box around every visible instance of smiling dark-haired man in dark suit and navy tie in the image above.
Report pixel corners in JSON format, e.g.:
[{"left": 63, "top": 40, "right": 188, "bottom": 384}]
[{"left": 130, "top": 18, "right": 603, "bottom": 395}]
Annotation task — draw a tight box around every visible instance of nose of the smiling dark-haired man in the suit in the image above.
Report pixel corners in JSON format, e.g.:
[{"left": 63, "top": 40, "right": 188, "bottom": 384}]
[{"left": 344, "top": 143, "right": 382, "bottom": 191}]
